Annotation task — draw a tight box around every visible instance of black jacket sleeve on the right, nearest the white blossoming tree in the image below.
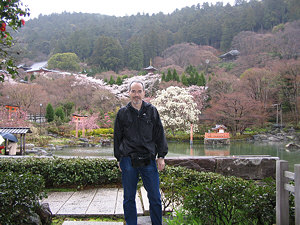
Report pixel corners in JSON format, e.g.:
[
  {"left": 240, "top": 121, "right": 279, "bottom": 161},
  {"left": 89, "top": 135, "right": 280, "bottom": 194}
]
[{"left": 153, "top": 107, "right": 168, "bottom": 158}]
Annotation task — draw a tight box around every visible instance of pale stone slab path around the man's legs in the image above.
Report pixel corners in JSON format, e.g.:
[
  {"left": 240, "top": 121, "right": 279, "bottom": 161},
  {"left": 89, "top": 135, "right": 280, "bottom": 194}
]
[{"left": 42, "top": 187, "right": 169, "bottom": 225}]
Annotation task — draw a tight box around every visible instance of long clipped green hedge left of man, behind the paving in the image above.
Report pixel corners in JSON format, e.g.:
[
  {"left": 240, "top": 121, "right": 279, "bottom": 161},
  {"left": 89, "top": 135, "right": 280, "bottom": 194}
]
[{"left": 0, "top": 157, "right": 121, "bottom": 188}]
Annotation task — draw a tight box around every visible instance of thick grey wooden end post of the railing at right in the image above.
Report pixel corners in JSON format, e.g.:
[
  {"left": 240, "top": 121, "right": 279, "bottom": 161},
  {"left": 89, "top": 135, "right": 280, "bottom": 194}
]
[{"left": 276, "top": 160, "right": 289, "bottom": 225}]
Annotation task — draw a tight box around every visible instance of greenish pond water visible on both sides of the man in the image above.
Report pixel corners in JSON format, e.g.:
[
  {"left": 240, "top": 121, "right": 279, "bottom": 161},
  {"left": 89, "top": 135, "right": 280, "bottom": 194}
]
[{"left": 53, "top": 142, "right": 300, "bottom": 171}]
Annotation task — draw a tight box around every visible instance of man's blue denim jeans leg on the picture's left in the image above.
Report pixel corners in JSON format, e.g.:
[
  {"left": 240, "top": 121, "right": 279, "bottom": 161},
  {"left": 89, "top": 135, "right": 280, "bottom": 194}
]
[{"left": 120, "top": 157, "right": 139, "bottom": 225}]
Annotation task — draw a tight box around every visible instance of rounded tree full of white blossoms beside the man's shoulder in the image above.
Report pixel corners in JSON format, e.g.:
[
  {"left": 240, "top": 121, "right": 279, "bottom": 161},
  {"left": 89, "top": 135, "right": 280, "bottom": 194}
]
[{"left": 151, "top": 86, "right": 200, "bottom": 135}]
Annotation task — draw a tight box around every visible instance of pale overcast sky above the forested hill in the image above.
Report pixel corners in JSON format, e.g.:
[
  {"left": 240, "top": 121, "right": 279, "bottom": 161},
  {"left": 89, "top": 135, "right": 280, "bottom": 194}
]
[{"left": 21, "top": 0, "right": 235, "bottom": 19}]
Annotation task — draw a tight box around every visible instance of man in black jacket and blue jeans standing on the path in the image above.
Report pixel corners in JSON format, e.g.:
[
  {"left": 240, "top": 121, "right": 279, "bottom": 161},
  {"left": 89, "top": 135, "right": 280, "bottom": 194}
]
[{"left": 114, "top": 81, "right": 168, "bottom": 225}]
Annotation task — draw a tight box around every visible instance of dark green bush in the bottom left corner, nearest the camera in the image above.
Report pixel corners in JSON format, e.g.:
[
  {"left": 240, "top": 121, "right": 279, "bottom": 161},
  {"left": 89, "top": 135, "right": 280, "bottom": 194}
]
[{"left": 0, "top": 171, "right": 45, "bottom": 225}]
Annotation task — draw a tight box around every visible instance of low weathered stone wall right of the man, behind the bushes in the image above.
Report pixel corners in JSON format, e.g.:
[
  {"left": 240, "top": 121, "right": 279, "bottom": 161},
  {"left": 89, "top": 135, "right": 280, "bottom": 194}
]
[{"left": 165, "top": 156, "right": 279, "bottom": 180}]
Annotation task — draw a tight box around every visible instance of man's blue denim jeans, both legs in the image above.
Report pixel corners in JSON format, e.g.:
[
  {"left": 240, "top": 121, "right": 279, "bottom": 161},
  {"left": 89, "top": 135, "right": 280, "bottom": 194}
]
[{"left": 120, "top": 157, "right": 162, "bottom": 225}]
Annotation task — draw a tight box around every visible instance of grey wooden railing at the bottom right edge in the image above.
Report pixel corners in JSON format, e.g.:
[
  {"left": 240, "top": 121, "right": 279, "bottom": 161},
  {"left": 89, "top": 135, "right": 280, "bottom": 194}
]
[{"left": 276, "top": 160, "right": 300, "bottom": 225}]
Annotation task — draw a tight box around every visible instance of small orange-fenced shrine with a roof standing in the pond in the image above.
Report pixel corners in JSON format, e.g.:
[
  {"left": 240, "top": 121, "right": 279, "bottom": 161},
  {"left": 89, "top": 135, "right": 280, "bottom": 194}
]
[{"left": 204, "top": 125, "right": 230, "bottom": 145}]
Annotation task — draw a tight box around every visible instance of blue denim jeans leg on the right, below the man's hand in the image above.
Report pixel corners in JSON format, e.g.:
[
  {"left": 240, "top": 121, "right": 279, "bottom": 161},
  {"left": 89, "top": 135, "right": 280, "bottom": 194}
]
[{"left": 138, "top": 160, "right": 162, "bottom": 225}]
